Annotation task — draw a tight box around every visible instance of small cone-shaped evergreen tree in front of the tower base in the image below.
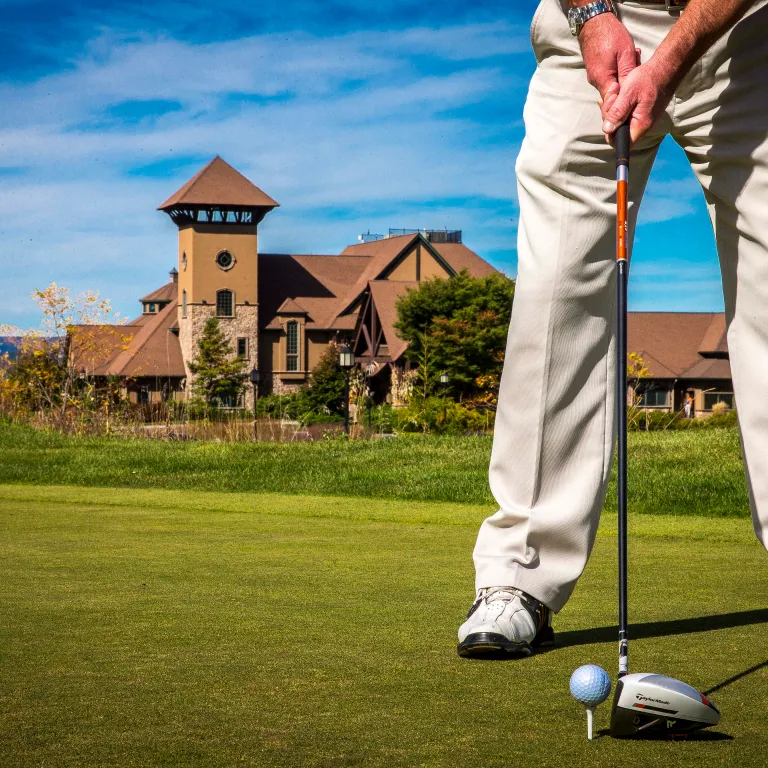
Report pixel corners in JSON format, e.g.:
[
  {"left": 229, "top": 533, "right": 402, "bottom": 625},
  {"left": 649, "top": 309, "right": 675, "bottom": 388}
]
[{"left": 189, "top": 317, "right": 248, "bottom": 403}]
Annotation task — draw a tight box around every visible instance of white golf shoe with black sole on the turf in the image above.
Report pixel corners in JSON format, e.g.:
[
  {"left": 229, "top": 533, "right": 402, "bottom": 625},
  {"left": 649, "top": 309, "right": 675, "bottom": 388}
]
[{"left": 456, "top": 587, "right": 555, "bottom": 657}]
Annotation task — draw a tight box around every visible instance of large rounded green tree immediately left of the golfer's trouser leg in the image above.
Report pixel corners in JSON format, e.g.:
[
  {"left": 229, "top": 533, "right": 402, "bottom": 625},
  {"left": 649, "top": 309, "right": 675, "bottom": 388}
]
[{"left": 395, "top": 270, "right": 515, "bottom": 395}]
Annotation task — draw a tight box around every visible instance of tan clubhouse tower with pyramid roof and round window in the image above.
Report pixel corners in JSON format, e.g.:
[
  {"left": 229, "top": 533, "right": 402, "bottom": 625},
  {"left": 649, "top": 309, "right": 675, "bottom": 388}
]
[{"left": 158, "top": 157, "right": 278, "bottom": 407}]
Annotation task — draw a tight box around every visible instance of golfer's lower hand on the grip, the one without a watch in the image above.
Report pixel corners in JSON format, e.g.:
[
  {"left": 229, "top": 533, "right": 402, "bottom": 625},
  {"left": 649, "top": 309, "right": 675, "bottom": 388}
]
[{"left": 603, "top": 59, "right": 674, "bottom": 144}]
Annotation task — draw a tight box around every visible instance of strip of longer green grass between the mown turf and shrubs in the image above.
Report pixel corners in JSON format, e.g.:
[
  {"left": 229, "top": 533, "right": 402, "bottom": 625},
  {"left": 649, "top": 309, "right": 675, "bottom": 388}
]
[{"left": 0, "top": 423, "right": 749, "bottom": 517}]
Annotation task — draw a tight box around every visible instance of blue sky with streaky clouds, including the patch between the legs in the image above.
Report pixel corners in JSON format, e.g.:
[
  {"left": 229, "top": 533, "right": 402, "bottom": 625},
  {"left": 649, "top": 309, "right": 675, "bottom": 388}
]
[{"left": 0, "top": 0, "right": 722, "bottom": 327}]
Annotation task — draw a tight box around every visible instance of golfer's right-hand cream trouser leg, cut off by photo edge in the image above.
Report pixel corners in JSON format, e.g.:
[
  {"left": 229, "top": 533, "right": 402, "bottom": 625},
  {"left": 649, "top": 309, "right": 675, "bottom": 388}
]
[{"left": 673, "top": 0, "right": 768, "bottom": 547}]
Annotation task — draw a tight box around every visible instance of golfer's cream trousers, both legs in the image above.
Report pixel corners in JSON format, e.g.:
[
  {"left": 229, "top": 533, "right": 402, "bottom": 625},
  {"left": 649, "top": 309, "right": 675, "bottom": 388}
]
[{"left": 474, "top": 0, "right": 768, "bottom": 611}]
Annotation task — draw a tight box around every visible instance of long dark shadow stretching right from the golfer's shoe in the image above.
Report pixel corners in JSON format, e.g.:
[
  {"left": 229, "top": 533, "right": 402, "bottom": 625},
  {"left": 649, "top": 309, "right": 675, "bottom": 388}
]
[{"left": 554, "top": 608, "right": 768, "bottom": 648}]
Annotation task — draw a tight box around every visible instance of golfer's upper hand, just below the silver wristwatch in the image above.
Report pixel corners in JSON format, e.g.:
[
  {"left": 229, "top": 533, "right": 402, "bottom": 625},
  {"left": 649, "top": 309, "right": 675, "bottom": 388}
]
[{"left": 579, "top": 13, "right": 637, "bottom": 120}]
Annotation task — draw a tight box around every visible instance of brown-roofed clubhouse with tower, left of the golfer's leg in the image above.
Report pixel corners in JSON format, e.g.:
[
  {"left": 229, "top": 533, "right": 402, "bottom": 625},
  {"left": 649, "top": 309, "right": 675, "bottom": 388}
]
[{"left": 70, "top": 157, "right": 496, "bottom": 405}]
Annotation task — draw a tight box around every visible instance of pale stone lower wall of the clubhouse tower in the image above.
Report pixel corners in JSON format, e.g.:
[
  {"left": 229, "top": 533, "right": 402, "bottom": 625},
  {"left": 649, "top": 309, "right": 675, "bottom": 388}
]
[{"left": 179, "top": 304, "right": 259, "bottom": 408}]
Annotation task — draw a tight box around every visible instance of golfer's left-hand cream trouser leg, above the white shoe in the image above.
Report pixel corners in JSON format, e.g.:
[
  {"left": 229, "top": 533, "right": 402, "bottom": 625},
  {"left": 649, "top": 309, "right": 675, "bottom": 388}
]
[{"left": 474, "top": 0, "right": 672, "bottom": 611}]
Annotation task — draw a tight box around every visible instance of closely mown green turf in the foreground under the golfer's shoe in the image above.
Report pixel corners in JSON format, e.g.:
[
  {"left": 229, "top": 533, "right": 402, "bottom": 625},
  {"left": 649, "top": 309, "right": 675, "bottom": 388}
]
[{"left": 0, "top": 485, "right": 768, "bottom": 768}]
